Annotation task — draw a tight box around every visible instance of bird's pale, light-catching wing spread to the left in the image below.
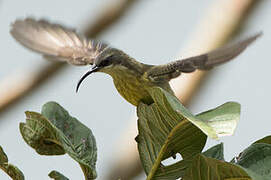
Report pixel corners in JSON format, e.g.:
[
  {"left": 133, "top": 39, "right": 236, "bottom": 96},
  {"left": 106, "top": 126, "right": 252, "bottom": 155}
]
[{"left": 10, "top": 18, "right": 108, "bottom": 65}]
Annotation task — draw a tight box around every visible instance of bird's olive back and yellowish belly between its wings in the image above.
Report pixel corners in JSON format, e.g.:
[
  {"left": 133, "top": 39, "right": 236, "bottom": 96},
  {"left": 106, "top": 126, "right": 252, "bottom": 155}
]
[{"left": 99, "top": 49, "right": 173, "bottom": 106}]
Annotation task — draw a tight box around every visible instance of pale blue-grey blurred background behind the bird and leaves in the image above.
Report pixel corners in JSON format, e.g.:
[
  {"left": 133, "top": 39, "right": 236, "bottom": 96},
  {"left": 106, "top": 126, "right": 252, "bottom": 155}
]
[{"left": 0, "top": 0, "right": 271, "bottom": 180}]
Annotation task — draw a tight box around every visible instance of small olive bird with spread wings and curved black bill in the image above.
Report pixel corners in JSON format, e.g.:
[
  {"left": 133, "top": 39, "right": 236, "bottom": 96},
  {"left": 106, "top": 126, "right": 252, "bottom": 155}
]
[{"left": 10, "top": 18, "right": 262, "bottom": 106}]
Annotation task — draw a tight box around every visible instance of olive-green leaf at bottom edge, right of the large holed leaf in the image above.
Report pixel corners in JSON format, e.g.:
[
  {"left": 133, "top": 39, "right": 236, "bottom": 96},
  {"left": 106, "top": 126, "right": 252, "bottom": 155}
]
[{"left": 183, "top": 154, "right": 252, "bottom": 180}]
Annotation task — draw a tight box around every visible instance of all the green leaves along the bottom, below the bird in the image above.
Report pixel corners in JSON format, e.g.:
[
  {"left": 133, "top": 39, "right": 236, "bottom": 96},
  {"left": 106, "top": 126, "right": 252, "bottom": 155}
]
[{"left": 0, "top": 88, "right": 271, "bottom": 180}]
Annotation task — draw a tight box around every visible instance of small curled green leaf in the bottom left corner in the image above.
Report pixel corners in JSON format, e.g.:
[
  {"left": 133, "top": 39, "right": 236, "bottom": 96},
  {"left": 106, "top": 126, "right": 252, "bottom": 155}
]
[{"left": 0, "top": 146, "right": 24, "bottom": 180}]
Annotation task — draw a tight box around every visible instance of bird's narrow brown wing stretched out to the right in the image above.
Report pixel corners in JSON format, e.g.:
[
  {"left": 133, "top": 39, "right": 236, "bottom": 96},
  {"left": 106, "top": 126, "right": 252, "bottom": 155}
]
[{"left": 146, "top": 33, "right": 262, "bottom": 80}]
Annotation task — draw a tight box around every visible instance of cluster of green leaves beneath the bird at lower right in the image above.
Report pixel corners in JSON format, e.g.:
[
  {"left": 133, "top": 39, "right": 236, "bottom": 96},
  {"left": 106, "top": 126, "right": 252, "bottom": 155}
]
[{"left": 137, "top": 88, "right": 271, "bottom": 180}]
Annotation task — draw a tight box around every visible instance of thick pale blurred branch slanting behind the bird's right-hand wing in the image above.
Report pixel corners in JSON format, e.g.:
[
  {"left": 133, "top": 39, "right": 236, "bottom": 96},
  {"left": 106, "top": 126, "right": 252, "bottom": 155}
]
[{"left": 106, "top": 0, "right": 263, "bottom": 179}]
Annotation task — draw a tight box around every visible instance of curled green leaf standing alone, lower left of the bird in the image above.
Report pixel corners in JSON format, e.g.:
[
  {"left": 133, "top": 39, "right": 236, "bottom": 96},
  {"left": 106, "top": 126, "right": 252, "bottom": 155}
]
[{"left": 20, "top": 102, "right": 97, "bottom": 179}]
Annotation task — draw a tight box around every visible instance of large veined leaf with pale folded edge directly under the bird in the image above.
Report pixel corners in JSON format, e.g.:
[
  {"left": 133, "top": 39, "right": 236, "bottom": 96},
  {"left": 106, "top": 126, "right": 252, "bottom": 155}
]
[{"left": 136, "top": 88, "right": 240, "bottom": 179}]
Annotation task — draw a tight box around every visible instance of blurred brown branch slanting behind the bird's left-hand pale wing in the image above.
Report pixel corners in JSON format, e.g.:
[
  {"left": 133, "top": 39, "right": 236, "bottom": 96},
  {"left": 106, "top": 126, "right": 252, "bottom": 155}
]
[{"left": 0, "top": 0, "right": 137, "bottom": 113}]
